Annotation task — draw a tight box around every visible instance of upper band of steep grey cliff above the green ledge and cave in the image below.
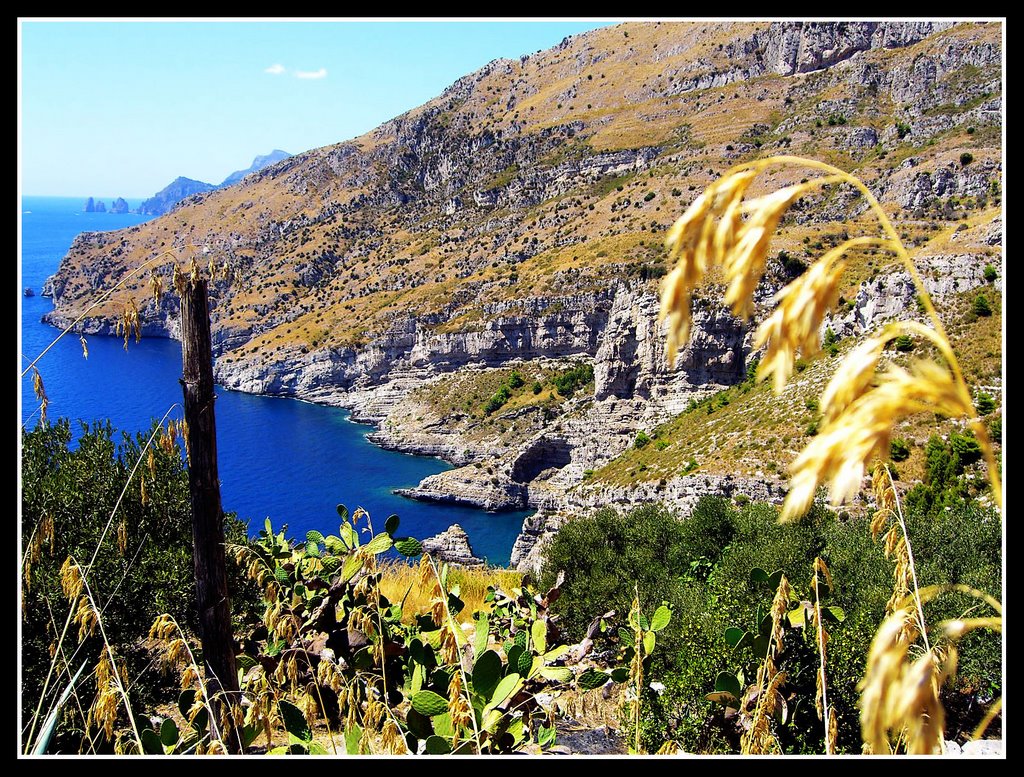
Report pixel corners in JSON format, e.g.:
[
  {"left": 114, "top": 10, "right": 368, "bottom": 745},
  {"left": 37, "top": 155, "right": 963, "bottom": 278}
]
[{"left": 215, "top": 283, "right": 748, "bottom": 425}]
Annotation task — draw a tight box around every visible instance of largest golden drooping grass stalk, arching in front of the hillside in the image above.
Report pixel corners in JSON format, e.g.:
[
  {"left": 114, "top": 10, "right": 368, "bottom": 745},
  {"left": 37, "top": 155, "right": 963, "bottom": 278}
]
[{"left": 660, "top": 157, "right": 1002, "bottom": 520}]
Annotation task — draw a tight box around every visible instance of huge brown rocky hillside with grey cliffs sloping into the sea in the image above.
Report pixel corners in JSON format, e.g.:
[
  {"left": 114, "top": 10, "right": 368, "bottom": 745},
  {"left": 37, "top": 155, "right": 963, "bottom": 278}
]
[{"left": 44, "top": 21, "right": 1001, "bottom": 559}]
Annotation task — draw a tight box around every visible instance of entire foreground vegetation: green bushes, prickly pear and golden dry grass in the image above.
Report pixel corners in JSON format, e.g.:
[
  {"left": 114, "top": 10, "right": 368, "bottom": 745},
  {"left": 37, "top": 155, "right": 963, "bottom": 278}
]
[{"left": 22, "top": 158, "right": 1002, "bottom": 754}]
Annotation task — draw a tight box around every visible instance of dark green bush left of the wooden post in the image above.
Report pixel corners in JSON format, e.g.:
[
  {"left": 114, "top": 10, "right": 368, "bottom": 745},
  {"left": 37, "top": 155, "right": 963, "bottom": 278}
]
[{"left": 20, "top": 419, "right": 253, "bottom": 750}]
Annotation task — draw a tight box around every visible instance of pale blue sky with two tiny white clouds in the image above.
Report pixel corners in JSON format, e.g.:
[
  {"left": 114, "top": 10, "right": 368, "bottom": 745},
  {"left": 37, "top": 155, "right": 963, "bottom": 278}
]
[{"left": 19, "top": 19, "right": 610, "bottom": 199}]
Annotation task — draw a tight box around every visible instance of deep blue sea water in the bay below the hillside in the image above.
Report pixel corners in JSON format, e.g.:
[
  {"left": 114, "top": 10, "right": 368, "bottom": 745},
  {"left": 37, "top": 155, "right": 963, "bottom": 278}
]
[{"left": 18, "top": 197, "right": 527, "bottom": 564}]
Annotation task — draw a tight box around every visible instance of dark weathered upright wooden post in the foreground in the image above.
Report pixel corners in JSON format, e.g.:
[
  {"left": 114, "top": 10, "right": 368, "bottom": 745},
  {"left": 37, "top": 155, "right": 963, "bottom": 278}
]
[{"left": 181, "top": 278, "right": 241, "bottom": 752}]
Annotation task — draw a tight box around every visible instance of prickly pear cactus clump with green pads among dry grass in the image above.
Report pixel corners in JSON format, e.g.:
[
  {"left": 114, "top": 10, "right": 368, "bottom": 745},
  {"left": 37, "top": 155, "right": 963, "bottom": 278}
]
[{"left": 147, "top": 506, "right": 625, "bottom": 754}]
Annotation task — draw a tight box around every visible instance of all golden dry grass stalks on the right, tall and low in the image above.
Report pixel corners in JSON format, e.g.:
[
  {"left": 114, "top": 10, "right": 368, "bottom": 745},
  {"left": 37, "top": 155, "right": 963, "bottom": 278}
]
[{"left": 662, "top": 156, "right": 1002, "bottom": 754}]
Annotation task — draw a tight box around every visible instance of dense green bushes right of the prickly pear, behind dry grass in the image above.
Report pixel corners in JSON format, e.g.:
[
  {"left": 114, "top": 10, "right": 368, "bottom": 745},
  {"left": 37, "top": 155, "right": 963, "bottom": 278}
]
[{"left": 545, "top": 497, "right": 1001, "bottom": 753}]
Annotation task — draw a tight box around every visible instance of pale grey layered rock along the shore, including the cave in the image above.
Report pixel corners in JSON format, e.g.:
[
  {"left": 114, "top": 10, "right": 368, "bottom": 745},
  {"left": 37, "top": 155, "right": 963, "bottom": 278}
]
[{"left": 37, "top": 240, "right": 1002, "bottom": 570}]
